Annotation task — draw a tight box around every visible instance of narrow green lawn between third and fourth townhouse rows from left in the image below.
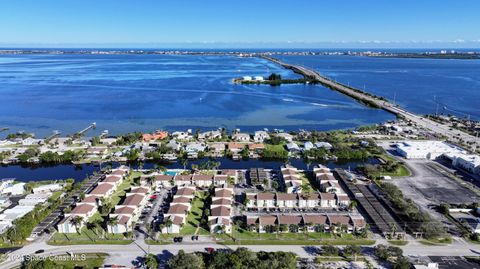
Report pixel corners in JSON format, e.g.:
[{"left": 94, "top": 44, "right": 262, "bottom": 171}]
[{"left": 180, "top": 188, "right": 210, "bottom": 235}]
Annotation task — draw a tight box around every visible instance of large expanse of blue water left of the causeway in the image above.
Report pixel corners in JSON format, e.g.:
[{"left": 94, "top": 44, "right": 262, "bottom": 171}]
[{"left": 0, "top": 54, "right": 393, "bottom": 137}]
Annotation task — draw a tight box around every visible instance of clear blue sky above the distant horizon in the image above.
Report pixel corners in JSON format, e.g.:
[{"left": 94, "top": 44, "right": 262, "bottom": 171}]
[{"left": 0, "top": 0, "right": 480, "bottom": 48}]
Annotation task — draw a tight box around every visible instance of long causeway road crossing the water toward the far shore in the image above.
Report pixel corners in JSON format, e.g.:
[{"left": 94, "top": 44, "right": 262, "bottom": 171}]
[{"left": 262, "top": 56, "right": 480, "bottom": 149}]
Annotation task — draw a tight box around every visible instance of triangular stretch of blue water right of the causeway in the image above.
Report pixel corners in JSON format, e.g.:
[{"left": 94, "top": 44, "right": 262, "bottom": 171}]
[{"left": 278, "top": 56, "right": 480, "bottom": 120}]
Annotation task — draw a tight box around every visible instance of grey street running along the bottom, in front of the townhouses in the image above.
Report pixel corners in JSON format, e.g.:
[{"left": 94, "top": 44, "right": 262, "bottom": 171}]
[{"left": 0, "top": 237, "right": 480, "bottom": 269}]
